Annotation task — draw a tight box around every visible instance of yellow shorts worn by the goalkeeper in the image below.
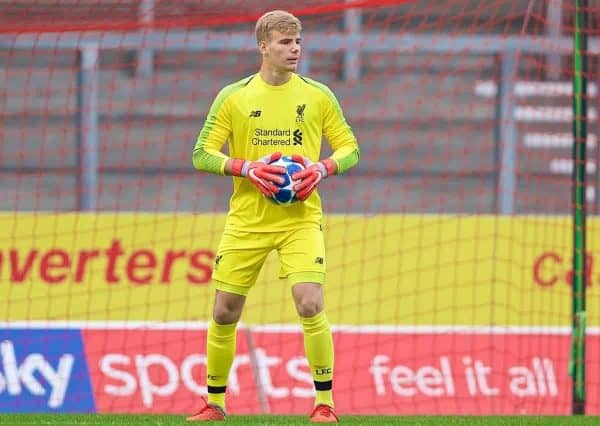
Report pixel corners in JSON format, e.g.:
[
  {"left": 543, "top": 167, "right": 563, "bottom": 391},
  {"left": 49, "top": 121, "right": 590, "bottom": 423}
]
[{"left": 212, "top": 228, "right": 326, "bottom": 296}]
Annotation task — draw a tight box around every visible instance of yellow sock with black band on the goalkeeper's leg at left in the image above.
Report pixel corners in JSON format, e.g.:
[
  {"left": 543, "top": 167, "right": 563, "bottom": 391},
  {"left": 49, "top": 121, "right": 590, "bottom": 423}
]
[{"left": 206, "top": 319, "right": 237, "bottom": 410}]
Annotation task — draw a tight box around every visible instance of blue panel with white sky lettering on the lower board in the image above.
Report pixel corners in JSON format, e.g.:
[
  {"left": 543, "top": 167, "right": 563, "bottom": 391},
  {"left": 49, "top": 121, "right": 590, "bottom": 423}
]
[{"left": 0, "top": 329, "right": 95, "bottom": 413}]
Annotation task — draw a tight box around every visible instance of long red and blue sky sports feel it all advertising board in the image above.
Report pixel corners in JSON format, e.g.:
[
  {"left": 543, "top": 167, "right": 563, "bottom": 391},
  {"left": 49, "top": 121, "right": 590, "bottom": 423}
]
[{"left": 0, "top": 325, "right": 600, "bottom": 414}]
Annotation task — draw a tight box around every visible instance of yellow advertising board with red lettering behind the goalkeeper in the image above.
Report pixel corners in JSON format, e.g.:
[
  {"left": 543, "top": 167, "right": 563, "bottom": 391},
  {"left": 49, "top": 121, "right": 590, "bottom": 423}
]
[{"left": 0, "top": 213, "right": 600, "bottom": 326}]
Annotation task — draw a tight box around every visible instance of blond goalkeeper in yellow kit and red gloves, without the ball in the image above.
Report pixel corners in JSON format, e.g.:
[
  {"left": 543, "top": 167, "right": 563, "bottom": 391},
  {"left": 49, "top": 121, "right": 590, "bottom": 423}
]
[{"left": 188, "top": 10, "right": 359, "bottom": 423}]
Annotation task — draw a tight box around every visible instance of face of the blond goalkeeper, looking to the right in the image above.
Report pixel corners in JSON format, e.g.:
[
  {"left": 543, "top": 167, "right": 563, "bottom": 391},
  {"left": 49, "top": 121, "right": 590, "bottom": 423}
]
[{"left": 259, "top": 30, "right": 301, "bottom": 71}]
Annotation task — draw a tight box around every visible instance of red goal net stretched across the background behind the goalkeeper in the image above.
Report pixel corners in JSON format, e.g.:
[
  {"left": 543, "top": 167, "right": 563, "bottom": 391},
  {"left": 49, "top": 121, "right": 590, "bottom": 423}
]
[{"left": 0, "top": 0, "right": 600, "bottom": 415}]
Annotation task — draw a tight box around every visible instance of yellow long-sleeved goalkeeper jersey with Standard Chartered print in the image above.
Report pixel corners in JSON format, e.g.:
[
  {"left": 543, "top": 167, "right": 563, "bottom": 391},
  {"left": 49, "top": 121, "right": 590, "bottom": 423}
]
[{"left": 193, "top": 74, "right": 360, "bottom": 232}]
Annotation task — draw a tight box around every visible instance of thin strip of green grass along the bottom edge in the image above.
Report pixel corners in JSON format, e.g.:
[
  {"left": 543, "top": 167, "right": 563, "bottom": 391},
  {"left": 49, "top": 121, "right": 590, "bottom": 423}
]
[{"left": 0, "top": 414, "right": 600, "bottom": 426}]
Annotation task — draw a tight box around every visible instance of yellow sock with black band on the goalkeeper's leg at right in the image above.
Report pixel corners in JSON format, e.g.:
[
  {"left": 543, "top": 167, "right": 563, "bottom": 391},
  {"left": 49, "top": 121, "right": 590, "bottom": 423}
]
[{"left": 300, "top": 311, "right": 333, "bottom": 407}]
